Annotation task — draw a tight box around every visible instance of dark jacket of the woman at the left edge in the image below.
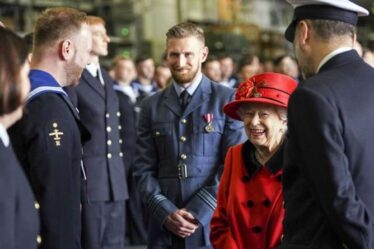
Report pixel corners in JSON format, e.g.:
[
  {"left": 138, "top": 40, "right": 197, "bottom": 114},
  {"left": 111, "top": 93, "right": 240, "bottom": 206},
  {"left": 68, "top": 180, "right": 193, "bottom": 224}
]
[{"left": 0, "top": 124, "right": 41, "bottom": 249}]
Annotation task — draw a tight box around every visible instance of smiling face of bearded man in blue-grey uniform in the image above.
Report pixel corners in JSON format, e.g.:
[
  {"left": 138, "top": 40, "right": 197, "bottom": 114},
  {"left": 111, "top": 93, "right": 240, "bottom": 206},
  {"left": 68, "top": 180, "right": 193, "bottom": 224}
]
[{"left": 166, "top": 36, "right": 208, "bottom": 84}]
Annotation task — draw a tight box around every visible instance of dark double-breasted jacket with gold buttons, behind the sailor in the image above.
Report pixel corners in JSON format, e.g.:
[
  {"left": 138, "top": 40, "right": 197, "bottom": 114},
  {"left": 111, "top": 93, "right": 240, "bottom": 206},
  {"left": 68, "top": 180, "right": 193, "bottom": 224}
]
[{"left": 67, "top": 69, "right": 128, "bottom": 201}]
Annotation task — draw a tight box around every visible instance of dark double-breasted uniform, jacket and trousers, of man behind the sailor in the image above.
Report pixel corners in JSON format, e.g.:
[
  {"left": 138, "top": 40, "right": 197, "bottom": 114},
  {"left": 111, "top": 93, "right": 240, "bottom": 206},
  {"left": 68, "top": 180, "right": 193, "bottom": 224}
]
[{"left": 68, "top": 67, "right": 128, "bottom": 249}]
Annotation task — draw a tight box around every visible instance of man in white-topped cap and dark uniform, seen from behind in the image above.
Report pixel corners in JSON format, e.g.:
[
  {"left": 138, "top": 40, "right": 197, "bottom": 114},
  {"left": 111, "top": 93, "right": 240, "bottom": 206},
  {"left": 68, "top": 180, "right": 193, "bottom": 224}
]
[{"left": 281, "top": 0, "right": 374, "bottom": 249}]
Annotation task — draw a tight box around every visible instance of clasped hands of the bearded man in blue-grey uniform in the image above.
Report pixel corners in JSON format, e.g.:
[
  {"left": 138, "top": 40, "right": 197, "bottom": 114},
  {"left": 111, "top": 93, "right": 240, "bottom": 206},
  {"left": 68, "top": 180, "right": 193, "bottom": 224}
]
[{"left": 165, "top": 209, "right": 198, "bottom": 238}]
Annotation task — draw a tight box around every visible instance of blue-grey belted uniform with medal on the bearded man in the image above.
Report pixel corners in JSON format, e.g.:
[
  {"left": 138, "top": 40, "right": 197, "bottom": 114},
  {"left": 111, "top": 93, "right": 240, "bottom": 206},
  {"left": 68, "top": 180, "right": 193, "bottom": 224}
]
[{"left": 134, "top": 74, "right": 245, "bottom": 249}]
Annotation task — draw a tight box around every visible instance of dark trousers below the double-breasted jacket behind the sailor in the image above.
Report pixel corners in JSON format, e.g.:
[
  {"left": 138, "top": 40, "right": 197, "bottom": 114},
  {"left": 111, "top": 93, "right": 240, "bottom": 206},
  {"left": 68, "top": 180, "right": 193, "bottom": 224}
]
[{"left": 82, "top": 201, "right": 125, "bottom": 249}]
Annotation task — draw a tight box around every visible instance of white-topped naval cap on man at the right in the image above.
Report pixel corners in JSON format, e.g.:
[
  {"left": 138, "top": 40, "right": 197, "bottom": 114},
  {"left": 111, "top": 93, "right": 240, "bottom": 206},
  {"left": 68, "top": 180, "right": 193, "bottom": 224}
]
[{"left": 285, "top": 0, "right": 369, "bottom": 42}]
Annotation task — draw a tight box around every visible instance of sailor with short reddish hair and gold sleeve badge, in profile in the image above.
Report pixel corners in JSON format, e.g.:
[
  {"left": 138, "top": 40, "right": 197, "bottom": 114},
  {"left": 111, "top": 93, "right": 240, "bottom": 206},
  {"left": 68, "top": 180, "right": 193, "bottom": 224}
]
[{"left": 11, "top": 8, "right": 91, "bottom": 249}]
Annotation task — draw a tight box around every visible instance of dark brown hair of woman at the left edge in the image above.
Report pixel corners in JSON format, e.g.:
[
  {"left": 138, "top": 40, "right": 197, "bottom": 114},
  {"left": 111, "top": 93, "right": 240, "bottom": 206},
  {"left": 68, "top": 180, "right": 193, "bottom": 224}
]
[{"left": 0, "top": 27, "right": 28, "bottom": 115}]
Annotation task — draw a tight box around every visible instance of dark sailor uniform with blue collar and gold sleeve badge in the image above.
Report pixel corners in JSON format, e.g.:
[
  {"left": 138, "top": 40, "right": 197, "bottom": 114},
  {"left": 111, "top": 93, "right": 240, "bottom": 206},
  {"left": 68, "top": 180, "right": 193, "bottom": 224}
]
[{"left": 10, "top": 70, "right": 86, "bottom": 249}]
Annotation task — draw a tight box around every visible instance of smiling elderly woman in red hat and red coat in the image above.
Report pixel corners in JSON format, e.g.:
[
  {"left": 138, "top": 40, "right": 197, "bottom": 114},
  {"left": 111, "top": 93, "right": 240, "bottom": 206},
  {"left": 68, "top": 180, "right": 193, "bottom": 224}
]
[{"left": 210, "top": 73, "right": 297, "bottom": 249}]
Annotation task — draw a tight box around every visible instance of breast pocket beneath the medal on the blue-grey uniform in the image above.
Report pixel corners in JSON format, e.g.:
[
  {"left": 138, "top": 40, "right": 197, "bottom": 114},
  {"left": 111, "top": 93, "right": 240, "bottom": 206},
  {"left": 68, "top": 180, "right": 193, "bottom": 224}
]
[{"left": 193, "top": 119, "right": 225, "bottom": 156}]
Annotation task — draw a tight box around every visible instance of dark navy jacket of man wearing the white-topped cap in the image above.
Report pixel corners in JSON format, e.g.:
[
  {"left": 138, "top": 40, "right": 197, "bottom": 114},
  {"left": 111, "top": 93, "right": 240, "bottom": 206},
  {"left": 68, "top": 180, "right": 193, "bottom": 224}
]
[{"left": 281, "top": 50, "right": 374, "bottom": 249}]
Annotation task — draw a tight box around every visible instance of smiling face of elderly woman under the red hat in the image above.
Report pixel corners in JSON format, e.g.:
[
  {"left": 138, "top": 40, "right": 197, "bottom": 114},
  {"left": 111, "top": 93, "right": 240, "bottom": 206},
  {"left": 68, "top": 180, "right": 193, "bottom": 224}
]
[{"left": 239, "top": 103, "right": 287, "bottom": 151}]
